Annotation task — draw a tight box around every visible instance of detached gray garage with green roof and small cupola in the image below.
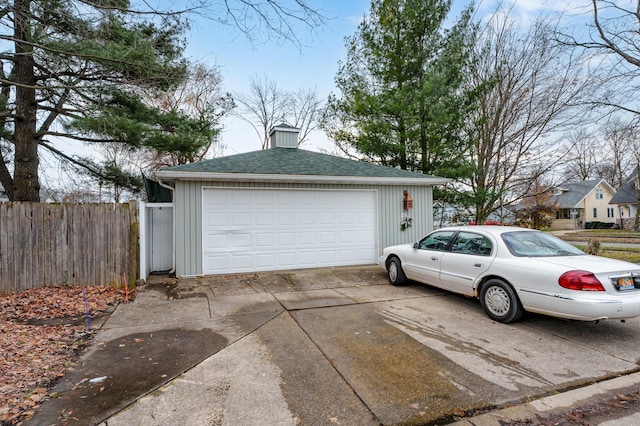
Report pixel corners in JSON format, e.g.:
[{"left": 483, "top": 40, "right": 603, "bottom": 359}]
[{"left": 156, "top": 125, "right": 447, "bottom": 277}]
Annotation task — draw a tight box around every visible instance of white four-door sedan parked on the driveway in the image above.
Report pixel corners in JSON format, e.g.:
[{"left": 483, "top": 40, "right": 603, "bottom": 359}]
[{"left": 378, "top": 226, "right": 640, "bottom": 323}]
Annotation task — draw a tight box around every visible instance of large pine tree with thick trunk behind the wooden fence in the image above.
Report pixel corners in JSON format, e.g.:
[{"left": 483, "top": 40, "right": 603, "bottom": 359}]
[{"left": 0, "top": 0, "right": 192, "bottom": 201}]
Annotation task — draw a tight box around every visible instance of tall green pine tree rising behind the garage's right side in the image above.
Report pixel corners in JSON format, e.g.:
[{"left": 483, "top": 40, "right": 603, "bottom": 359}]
[{"left": 324, "top": 0, "right": 475, "bottom": 177}]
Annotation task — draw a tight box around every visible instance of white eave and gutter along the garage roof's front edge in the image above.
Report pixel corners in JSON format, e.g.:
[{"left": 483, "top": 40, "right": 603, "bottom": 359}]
[{"left": 156, "top": 170, "right": 450, "bottom": 186}]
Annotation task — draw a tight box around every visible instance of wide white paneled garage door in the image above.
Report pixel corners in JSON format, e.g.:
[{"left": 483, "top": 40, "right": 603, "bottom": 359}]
[{"left": 202, "top": 188, "right": 377, "bottom": 274}]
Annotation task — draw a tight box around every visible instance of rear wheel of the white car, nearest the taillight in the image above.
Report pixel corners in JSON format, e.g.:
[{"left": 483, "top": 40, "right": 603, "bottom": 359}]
[{"left": 480, "top": 278, "right": 524, "bottom": 324}]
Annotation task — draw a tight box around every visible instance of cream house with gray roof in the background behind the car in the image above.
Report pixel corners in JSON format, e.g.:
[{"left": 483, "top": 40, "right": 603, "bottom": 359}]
[{"left": 551, "top": 179, "right": 616, "bottom": 229}]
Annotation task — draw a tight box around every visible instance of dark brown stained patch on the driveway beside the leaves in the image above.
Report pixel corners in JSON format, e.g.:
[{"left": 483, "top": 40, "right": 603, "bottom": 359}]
[{"left": 29, "top": 329, "right": 228, "bottom": 425}]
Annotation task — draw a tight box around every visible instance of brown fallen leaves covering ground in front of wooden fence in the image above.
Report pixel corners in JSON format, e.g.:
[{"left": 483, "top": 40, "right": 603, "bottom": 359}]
[{"left": 0, "top": 285, "right": 136, "bottom": 425}]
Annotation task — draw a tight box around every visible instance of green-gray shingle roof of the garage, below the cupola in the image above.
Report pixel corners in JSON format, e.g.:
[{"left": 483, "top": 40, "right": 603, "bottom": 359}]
[{"left": 159, "top": 148, "right": 434, "bottom": 179}]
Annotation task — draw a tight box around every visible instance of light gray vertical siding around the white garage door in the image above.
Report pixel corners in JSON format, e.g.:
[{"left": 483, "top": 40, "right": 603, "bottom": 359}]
[{"left": 174, "top": 181, "right": 433, "bottom": 276}]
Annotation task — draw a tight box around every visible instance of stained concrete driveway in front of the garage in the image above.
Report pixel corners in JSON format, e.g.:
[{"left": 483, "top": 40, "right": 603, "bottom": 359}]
[{"left": 33, "top": 266, "right": 640, "bottom": 426}]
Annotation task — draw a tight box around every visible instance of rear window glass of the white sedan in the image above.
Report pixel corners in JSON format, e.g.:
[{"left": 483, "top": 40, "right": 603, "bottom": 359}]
[{"left": 502, "top": 231, "right": 585, "bottom": 257}]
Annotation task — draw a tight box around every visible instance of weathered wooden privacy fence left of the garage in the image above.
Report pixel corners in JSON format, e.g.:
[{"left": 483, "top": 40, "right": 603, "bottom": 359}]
[{"left": 0, "top": 201, "right": 139, "bottom": 293}]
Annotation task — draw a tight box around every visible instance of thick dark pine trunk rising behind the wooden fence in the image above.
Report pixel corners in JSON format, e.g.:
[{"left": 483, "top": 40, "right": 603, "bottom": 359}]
[{"left": 12, "top": 0, "right": 40, "bottom": 202}]
